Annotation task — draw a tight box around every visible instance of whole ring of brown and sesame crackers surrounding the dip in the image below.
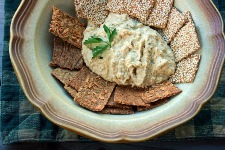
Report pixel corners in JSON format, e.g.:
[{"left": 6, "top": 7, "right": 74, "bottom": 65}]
[{"left": 49, "top": 0, "right": 200, "bottom": 114}]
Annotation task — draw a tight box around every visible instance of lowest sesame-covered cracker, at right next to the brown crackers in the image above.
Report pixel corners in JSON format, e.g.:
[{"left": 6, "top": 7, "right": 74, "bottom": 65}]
[{"left": 169, "top": 54, "right": 201, "bottom": 83}]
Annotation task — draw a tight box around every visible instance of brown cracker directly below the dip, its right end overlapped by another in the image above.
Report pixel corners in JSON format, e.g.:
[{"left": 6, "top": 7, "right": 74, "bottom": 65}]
[{"left": 114, "top": 86, "right": 149, "bottom": 106}]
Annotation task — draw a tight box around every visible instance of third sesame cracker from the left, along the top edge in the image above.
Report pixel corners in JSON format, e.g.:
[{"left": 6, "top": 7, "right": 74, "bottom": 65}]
[{"left": 127, "top": 0, "right": 155, "bottom": 23}]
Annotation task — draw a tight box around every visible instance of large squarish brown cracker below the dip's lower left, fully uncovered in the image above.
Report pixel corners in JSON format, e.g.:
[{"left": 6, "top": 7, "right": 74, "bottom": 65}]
[{"left": 74, "top": 72, "right": 116, "bottom": 111}]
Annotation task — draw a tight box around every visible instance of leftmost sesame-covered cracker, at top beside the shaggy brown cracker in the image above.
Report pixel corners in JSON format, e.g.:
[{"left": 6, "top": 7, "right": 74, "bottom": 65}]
[{"left": 76, "top": 0, "right": 109, "bottom": 26}]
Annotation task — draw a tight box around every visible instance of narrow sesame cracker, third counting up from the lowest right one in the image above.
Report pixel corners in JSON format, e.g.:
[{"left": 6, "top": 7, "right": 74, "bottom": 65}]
[{"left": 162, "top": 7, "right": 187, "bottom": 43}]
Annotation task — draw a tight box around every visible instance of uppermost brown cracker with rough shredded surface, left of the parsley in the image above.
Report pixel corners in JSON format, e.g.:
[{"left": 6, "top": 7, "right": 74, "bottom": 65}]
[{"left": 49, "top": 7, "right": 85, "bottom": 49}]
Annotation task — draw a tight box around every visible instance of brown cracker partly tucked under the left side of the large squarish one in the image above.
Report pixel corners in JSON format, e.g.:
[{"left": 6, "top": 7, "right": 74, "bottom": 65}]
[{"left": 67, "top": 66, "right": 91, "bottom": 91}]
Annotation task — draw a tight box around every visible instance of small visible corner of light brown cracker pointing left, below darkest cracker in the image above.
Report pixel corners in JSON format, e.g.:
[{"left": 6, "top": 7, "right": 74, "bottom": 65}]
[{"left": 51, "top": 68, "right": 77, "bottom": 84}]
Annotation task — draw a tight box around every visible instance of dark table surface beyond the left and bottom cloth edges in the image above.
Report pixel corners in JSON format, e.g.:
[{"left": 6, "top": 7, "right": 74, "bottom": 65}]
[{"left": 0, "top": 0, "right": 225, "bottom": 150}]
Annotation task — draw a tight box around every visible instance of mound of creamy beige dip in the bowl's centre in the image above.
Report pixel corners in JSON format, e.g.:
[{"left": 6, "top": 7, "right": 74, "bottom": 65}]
[{"left": 82, "top": 13, "right": 176, "bottom": 87}]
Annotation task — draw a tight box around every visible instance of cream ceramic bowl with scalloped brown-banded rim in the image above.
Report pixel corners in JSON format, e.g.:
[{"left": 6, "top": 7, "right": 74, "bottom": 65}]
[{"left": 9, "top": 0, "right": 225, "bottom": 142}]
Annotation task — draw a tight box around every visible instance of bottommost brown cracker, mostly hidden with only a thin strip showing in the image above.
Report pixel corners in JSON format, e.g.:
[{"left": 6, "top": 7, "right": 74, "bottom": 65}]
[{"left": 100, "top": 107, "right": 134, "bottom": 115}]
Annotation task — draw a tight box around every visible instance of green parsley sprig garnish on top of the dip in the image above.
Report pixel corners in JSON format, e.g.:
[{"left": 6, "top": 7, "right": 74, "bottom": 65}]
[{"left": 84, "top": 25, "right": 117, "bottom": 59}]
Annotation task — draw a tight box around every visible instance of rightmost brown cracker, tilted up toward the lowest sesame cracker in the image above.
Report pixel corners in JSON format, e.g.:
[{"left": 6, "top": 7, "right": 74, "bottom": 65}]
[{"left": 142, "top": 81, "right": 182, "bottom": 103}]
